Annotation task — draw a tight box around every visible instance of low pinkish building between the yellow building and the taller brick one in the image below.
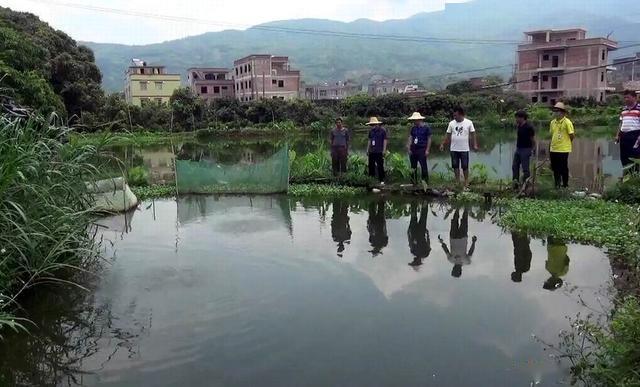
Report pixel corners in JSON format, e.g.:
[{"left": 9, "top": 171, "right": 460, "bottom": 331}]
[{"left": 187, "top": 67, "right": 235, "bottom": 102}]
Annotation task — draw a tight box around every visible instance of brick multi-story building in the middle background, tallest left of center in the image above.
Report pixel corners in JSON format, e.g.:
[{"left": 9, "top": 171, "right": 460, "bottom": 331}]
[{"left": 233, "top": 55, "right": 300, "bottom": 101}]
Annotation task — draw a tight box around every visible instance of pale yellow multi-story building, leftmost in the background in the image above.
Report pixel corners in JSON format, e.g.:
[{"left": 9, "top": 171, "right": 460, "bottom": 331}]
[{"left": 124, "top": 59, "right": 180, "bottom": 106}]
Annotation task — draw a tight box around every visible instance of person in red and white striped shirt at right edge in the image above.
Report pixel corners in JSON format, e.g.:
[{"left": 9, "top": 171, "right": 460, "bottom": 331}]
[{"left": 616, "top": 90, "right": 640, "bottom": 171}]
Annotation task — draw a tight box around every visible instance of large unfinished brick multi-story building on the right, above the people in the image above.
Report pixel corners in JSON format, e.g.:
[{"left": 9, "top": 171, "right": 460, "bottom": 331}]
[{"left": 516, "top": 28, "right": 618, "bottom": 104}]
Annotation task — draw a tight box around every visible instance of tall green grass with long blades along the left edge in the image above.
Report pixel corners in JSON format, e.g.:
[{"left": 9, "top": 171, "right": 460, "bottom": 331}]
[{"left": 0, "top": 116, "right": 102, "bottom": 329}]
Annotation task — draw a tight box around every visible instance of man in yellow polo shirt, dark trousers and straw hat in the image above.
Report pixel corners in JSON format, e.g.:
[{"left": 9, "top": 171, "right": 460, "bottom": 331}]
[{"left": 549, "top": 102, "right": 575, "bottom": 188}]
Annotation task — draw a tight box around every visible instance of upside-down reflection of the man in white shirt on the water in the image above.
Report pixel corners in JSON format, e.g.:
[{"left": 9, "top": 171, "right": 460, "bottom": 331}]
[{"left": 438, "top": 208, "right": 478, "bottom": 278}]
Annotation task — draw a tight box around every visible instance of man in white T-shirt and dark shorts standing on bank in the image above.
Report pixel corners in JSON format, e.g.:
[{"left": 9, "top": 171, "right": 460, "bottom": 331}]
[{"left": 440, "top": 107, "right": 478, "bottom": 188}]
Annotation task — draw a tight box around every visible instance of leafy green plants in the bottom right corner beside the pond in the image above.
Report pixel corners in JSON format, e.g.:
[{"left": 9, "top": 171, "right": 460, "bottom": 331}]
[{"left": 558, "top": 296, "right": 640, "bottom": 387}]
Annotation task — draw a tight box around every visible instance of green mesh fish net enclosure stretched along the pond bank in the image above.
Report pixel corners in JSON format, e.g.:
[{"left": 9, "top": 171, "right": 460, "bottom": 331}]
[{"left": 176, "top": 146, "right": 289, "bottom": 194}]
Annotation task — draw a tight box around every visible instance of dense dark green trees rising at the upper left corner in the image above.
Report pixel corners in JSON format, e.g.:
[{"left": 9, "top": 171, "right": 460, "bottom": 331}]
[{"left": 0, "top": 7, "right": 104, "bottom": 118}]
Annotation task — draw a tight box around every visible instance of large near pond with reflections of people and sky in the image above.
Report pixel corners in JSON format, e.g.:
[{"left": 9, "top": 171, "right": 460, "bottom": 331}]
[{"left": 0, "top": 196, "right": 611, "bottom": 387}]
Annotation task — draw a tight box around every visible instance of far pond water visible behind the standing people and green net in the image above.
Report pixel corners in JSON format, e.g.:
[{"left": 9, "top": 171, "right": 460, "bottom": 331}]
[{"left": 107, "top": 131, "right": 622, "bottom": 190}]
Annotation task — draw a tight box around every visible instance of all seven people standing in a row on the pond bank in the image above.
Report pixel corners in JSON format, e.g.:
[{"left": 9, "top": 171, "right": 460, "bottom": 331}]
[{"left": 330, "top": 91, "right": 640, "bottom": 188}]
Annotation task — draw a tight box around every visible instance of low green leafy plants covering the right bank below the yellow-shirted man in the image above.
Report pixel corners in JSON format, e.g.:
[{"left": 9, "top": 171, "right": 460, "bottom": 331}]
[{"left": 500, "top": 199, "right": 640, "bottom": 263}]
